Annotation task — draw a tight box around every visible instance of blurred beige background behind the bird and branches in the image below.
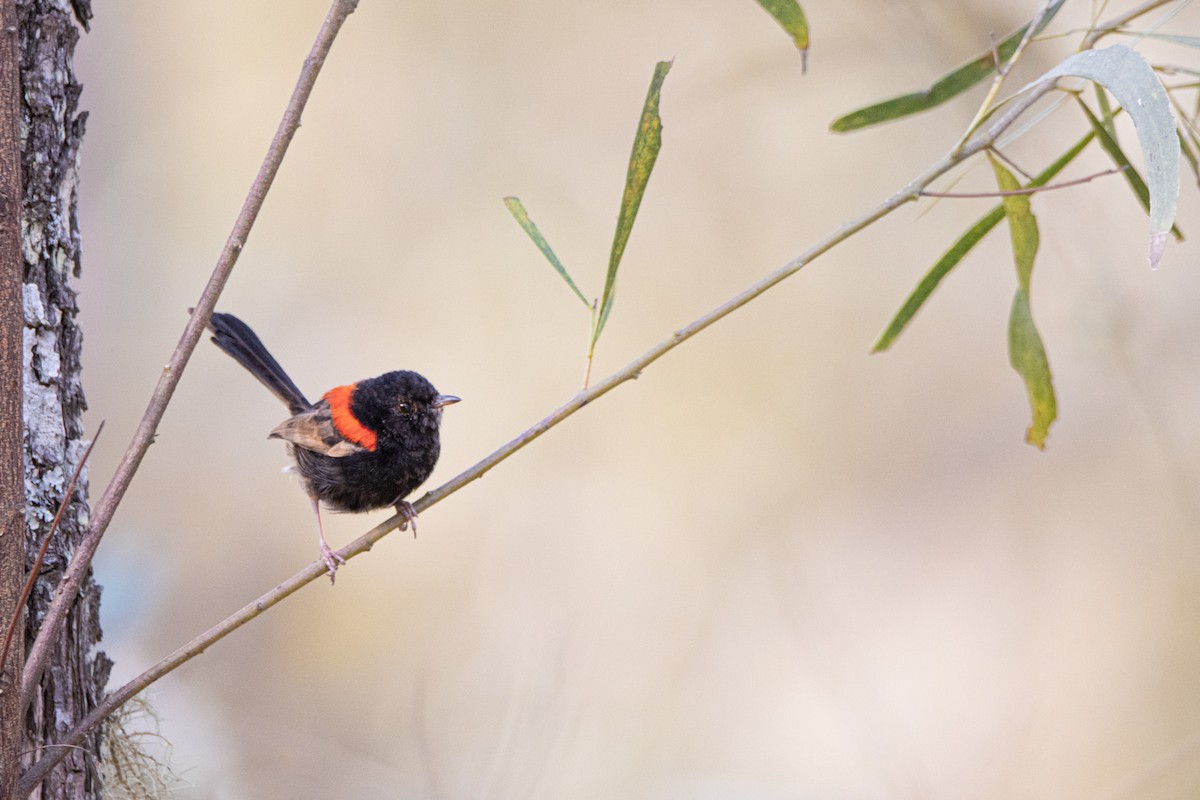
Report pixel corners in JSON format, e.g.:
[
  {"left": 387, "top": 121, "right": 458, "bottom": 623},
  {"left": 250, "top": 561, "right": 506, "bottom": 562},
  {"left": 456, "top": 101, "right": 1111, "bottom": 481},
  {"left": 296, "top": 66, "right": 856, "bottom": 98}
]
[{"left": 78, "top": 0, "right": 1200, "bottom": 800}]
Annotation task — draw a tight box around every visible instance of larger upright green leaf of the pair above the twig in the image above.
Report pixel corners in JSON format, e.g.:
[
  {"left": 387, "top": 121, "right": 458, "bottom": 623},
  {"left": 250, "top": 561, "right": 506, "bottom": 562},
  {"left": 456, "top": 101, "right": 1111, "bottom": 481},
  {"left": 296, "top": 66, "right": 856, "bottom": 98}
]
[{"left": 592, "top": 61, "right": 672, "bottom": 347}]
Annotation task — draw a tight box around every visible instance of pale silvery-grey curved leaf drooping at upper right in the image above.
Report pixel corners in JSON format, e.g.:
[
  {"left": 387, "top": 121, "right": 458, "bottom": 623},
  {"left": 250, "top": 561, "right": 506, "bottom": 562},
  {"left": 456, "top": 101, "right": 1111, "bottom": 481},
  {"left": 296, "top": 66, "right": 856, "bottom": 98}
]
[{"left": 1026, "top": 44, "right": 1180, "bottom": 267}]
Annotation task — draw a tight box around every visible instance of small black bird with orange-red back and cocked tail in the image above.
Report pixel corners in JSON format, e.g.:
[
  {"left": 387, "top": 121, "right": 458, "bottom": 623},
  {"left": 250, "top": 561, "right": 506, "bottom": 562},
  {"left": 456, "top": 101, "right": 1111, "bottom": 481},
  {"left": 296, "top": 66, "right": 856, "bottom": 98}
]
[{"left": 209, "top": 313, "right": 460, "bottom": 581}]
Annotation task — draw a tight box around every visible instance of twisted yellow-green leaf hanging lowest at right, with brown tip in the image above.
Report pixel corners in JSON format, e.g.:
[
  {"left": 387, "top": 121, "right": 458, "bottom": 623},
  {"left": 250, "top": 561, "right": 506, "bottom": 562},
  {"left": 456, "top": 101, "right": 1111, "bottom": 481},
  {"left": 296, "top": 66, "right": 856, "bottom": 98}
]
[{"left": 988, "top": 154, "right": 1057, "bottom": 447}]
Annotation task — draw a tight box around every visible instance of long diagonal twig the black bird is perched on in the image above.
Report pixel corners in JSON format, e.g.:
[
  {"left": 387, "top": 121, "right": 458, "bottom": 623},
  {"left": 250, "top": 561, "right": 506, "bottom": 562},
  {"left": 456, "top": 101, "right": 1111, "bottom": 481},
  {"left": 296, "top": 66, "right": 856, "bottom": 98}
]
[{"left": 18, "top": 0, "right": 1185, "bottom": 796}]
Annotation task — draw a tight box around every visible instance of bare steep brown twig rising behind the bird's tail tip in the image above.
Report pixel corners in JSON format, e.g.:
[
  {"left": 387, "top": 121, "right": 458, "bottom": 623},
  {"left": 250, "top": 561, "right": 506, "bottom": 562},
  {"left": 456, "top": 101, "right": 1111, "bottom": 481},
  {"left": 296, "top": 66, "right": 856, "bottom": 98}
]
[{"left": 20, "top": 0, "right": 358, "bottom": 724}]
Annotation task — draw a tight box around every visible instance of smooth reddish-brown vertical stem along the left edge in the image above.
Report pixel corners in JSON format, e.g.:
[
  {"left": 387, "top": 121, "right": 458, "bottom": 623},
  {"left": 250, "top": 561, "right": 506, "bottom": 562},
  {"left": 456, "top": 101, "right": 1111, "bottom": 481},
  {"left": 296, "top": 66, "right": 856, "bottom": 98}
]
[{"left": 0, "top": 0, "right": 25, "bottom": 798}]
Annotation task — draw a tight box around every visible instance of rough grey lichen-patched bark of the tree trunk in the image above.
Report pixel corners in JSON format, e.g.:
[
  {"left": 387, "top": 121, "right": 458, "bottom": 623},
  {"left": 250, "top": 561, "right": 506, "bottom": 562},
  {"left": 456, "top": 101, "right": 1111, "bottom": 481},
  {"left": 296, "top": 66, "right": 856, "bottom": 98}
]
[{"left": 17, "top": 0, "right": 110, "bottom": 800}]
